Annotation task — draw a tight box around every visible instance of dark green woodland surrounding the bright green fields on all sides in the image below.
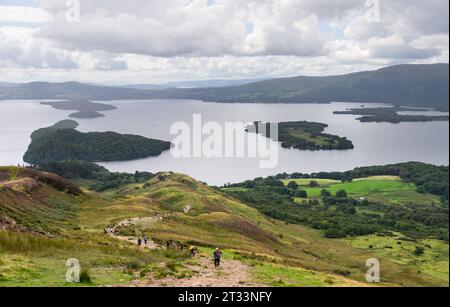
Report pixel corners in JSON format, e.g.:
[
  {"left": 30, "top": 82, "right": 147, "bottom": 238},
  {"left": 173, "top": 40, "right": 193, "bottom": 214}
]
[{"left": 222, "top": 163, "right": 449, "bottom": 242}]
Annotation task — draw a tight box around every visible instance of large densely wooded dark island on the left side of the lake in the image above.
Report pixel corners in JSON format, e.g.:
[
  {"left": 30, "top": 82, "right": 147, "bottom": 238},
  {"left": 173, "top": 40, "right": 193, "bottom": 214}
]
[{"left": 23, "top": 120, "right": 171, "bottom": 165}]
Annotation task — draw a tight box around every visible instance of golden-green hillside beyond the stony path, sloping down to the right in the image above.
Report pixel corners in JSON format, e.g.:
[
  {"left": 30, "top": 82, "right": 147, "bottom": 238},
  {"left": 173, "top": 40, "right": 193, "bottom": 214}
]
[{"left": 82, "top": 174, "right": 442, "bottom": 285}]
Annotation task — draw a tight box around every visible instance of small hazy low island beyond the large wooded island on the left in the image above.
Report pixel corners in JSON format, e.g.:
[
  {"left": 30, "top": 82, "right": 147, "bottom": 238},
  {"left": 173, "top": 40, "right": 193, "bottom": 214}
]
[{"left": 41, "top": 100, "right": 117, "bottom": 119}]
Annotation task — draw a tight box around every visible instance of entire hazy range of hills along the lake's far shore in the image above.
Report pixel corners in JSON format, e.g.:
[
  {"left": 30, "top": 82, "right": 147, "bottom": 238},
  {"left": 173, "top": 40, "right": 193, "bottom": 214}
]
[{"left": 0, "top": 64, "right": 449, "bottom": 111}]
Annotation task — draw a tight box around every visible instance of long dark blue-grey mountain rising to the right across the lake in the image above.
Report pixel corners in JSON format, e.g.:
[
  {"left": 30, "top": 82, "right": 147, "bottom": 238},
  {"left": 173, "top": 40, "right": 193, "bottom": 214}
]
[{"left": 152, "top": 64, "right": 449, "bottom": 110}]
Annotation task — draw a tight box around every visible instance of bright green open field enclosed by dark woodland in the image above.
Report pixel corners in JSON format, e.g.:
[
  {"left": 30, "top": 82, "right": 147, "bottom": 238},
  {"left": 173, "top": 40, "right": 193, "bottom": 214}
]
[{"left": 283, "top": 176, "right": 440, "bottom": 205}]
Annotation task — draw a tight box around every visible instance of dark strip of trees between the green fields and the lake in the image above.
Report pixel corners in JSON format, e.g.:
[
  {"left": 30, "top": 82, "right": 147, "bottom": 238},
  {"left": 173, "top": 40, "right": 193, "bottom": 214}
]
[{"left": 230, "top": 162, "right": 449, "bottom": 203}]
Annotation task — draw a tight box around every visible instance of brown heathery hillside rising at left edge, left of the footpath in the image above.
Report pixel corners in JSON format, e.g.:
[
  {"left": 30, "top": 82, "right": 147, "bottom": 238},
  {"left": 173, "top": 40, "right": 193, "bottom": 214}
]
[{"left": 0, "top": 167, "right": 83, "bottom": 234}]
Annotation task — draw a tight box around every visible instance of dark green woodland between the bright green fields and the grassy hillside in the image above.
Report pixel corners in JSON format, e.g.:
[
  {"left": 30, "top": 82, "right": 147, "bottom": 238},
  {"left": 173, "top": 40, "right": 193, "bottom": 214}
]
[{"left": 225, "top": 177, "right": 449, "bottom": 241}]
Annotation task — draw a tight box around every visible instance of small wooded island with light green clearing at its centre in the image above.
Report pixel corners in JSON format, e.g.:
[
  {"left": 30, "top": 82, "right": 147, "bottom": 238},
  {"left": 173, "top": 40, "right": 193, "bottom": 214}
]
[{"left": 246, "top": 121, "right": 354, "bottom": 150}]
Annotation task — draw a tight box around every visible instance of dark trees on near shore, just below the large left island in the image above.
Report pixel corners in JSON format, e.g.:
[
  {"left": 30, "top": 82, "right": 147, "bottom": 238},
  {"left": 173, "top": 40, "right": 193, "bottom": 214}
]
[{"left": 39, "top": 160, "right": 154, "bottom": 192}]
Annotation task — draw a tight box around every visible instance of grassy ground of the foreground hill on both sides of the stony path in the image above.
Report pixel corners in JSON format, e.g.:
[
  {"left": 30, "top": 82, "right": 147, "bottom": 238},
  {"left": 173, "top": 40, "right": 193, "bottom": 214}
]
[{"left": 0, "top": 170, "right": 448, "bottom": 286}]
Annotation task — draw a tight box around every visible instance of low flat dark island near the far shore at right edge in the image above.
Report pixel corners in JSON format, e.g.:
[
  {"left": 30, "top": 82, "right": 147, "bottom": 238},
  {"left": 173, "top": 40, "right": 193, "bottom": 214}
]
[{"left": 334, "top": 107, "right": 449, "bottom": 124}]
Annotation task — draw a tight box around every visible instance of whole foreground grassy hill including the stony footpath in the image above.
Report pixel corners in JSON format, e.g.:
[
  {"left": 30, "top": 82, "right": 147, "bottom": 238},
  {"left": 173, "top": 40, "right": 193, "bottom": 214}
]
[{"left": 0, "top": 168, "right": 448, "bottom": 286}]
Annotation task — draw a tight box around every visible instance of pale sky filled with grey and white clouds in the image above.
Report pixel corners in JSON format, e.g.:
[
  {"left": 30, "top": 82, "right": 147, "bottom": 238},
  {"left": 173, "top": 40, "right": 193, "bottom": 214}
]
[{"left": 0, "top": 0, "right": 449, "bottom": 84}]
